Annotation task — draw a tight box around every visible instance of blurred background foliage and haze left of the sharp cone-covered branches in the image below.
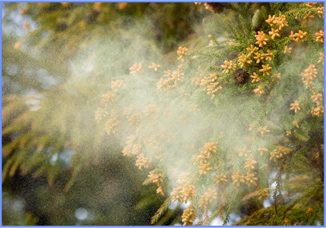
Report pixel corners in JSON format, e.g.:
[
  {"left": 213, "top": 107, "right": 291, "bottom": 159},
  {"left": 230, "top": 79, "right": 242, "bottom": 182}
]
[{"left": 2, "top": 2, "right": 210, "bottom": 225}]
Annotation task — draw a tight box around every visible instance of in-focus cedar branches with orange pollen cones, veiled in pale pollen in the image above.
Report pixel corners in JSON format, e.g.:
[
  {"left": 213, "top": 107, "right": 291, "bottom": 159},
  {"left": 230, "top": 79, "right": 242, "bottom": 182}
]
[{"left": 96, "top": 3, "right": 324, "bottom": 225}]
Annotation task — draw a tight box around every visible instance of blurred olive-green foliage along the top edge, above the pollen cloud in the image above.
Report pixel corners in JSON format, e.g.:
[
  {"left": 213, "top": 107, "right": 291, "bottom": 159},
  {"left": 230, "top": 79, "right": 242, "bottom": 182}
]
[{"left": 5, "top": 2, "right": 201, "bottom": 58}]
